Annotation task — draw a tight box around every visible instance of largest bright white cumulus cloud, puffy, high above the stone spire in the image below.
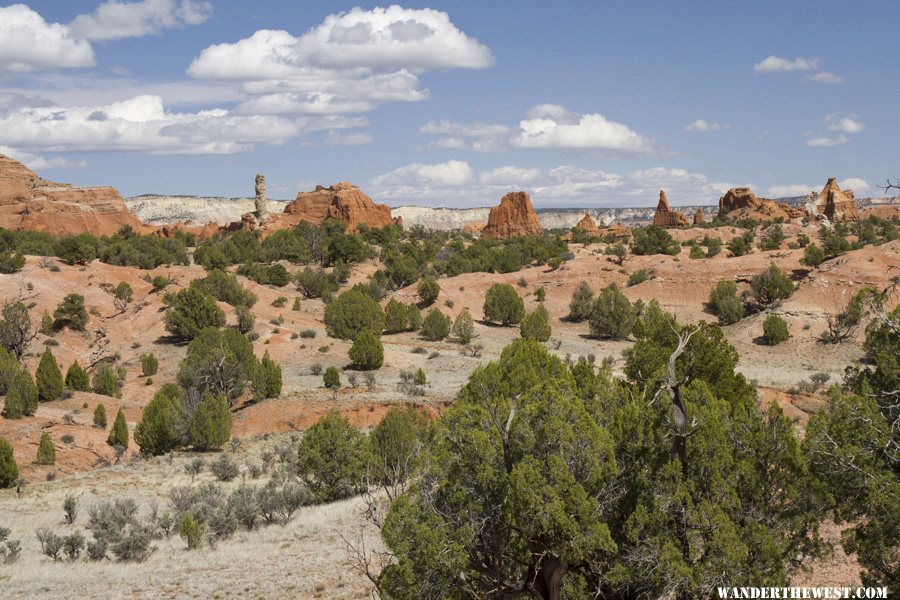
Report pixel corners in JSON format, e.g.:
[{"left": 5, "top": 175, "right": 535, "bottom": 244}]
[{"left": 188, "top": 6, "right": 494, "bottom": 114}]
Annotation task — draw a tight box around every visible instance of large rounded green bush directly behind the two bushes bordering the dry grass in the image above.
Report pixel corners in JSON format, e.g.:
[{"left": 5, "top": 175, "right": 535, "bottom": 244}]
[{"left": 177, "top": 327, "right": 259, "bottom": 404}]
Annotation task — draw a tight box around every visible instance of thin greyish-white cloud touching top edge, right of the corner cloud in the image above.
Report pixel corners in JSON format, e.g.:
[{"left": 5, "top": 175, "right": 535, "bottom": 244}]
[{"left": 69, "top": 0, "right": 213, "bottom": 41}]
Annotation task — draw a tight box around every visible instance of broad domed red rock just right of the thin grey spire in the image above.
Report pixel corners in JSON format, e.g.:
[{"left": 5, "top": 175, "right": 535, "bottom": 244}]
[{"left": 263, "top": 181, "right": 395, "bottom": 233}]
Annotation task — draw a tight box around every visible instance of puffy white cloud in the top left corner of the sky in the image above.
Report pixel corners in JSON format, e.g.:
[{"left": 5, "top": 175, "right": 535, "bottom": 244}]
[{"left": 0, "top": 4, "right": 94, "bottom": 73}]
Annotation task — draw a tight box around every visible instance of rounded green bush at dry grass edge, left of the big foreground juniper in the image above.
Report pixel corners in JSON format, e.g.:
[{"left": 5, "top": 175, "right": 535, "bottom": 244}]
[{"left": 297, "top": 410, "right": 368, "bottom": 502}]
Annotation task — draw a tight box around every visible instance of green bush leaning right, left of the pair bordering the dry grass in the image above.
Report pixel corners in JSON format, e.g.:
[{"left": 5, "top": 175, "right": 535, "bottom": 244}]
[{"left": 134, "top": 383, "right": 186, "bottom": 456}]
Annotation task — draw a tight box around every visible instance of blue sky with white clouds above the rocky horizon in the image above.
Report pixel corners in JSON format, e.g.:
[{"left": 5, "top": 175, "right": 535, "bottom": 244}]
[{"left": 0, "top": 0, "right": 900, "bottom": 207}]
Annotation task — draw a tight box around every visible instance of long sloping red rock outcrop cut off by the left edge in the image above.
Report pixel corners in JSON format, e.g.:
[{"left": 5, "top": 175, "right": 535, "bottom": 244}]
[{"left": 0, "top": 154, "right": 152, "bottom": 236}]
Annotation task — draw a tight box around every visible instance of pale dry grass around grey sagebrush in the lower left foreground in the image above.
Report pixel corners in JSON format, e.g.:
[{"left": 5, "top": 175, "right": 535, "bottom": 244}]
[{"left": 0, "top": 436, "right": 380, "bottom": 599}]
